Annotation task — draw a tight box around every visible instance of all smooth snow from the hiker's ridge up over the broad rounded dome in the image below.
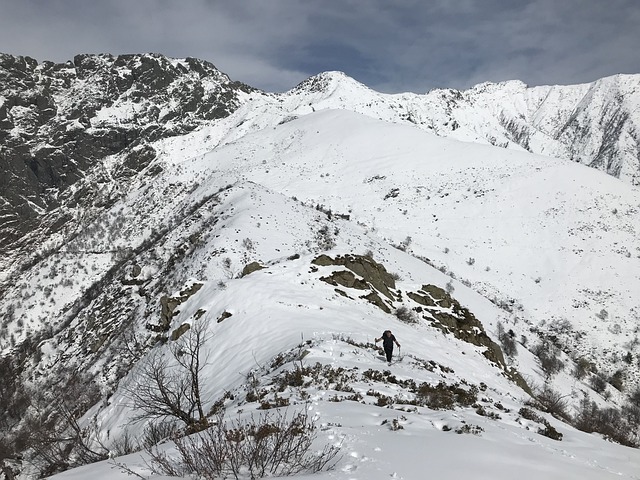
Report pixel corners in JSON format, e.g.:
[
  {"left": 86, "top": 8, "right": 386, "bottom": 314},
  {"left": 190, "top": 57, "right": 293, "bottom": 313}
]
[{"left": 38, "top": 110, "right": 640, "bottom": 479}]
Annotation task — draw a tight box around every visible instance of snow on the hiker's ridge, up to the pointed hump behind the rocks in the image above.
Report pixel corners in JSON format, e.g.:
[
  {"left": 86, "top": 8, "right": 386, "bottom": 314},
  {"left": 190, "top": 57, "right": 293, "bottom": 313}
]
[{"left": 35, "top": 178, "right": 640, "bottom": 480}]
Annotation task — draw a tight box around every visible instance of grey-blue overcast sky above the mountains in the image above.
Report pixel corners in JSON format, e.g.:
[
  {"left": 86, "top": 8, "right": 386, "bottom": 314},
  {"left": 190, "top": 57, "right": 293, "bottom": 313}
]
[{"left": 0, "top": 0, "right": 640, "bottom": 93}]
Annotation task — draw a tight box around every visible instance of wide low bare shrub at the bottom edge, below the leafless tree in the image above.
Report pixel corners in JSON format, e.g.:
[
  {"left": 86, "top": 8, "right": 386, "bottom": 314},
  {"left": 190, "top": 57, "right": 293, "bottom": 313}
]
[{"left": 148, "top": 412, "right": 340, "bottom": 479}]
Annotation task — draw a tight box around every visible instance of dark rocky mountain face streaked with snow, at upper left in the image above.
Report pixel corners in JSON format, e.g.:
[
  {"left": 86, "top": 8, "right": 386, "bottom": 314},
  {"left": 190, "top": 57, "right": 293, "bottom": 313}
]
[{"left": 0, "top": 54, "right": 252, "bottom": 264}]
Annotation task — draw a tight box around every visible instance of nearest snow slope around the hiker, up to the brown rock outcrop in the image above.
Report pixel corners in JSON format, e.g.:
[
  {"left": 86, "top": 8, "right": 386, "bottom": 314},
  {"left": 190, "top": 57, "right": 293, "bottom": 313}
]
[{"left": 47, "top": 227, "right": 640, "bottom": 480}]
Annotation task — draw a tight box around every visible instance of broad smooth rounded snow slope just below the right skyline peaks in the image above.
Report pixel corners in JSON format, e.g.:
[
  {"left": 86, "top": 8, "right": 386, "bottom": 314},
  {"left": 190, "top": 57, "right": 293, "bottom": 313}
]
[{"left": 166, "top": 110, "right": 640, "bottom": 378}]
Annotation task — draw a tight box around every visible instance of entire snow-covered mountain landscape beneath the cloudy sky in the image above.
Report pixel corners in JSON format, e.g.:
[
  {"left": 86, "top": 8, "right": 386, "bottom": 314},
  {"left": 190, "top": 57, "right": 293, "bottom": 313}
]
[{"left": 0, "top": 55, "right": 640, "bottom": 479}]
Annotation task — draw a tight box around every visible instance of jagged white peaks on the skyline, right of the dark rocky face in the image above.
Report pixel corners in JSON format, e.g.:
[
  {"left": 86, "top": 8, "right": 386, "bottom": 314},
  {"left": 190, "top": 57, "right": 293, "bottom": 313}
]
[{"left": 281, "top": 72, "right": 640, "bottom": 184}]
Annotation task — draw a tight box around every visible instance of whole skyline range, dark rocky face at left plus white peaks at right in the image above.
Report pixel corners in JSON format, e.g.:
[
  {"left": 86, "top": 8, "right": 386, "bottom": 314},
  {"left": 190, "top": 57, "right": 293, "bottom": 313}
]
[{"left": 0, "top": 54, "right": 640, "bottom": 262}]
